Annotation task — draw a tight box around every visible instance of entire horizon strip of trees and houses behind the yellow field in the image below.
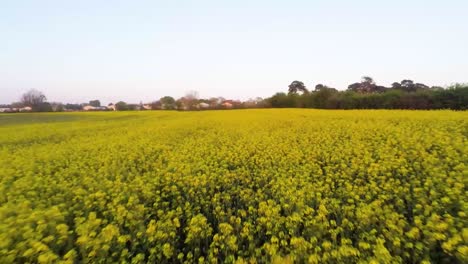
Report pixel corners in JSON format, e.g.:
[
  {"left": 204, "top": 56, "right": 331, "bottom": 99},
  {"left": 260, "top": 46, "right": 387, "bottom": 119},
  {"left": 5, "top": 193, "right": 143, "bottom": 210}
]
[{"left": 0, "top": 76, "right": 468, "bottom": 112}]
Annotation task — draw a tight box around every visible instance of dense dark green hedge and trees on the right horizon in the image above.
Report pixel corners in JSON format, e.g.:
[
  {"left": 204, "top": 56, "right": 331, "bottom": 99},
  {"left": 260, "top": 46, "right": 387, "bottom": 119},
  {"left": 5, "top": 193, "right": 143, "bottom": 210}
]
[{"left": 267, "top": 82, "right": 468, "bottom": 110}]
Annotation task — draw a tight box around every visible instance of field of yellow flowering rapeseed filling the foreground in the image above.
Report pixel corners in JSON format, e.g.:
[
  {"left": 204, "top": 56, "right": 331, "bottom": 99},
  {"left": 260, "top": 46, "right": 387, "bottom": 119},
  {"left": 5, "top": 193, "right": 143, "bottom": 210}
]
[{"left": 0, "top": 109, "right": 468, "bottom": 263}]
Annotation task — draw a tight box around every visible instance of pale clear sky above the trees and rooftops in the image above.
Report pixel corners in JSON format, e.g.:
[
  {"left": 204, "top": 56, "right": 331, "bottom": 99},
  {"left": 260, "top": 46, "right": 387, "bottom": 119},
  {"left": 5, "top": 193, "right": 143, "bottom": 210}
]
[{"left": 0, "top": 0, "right": 468, "bottom": 103}]
